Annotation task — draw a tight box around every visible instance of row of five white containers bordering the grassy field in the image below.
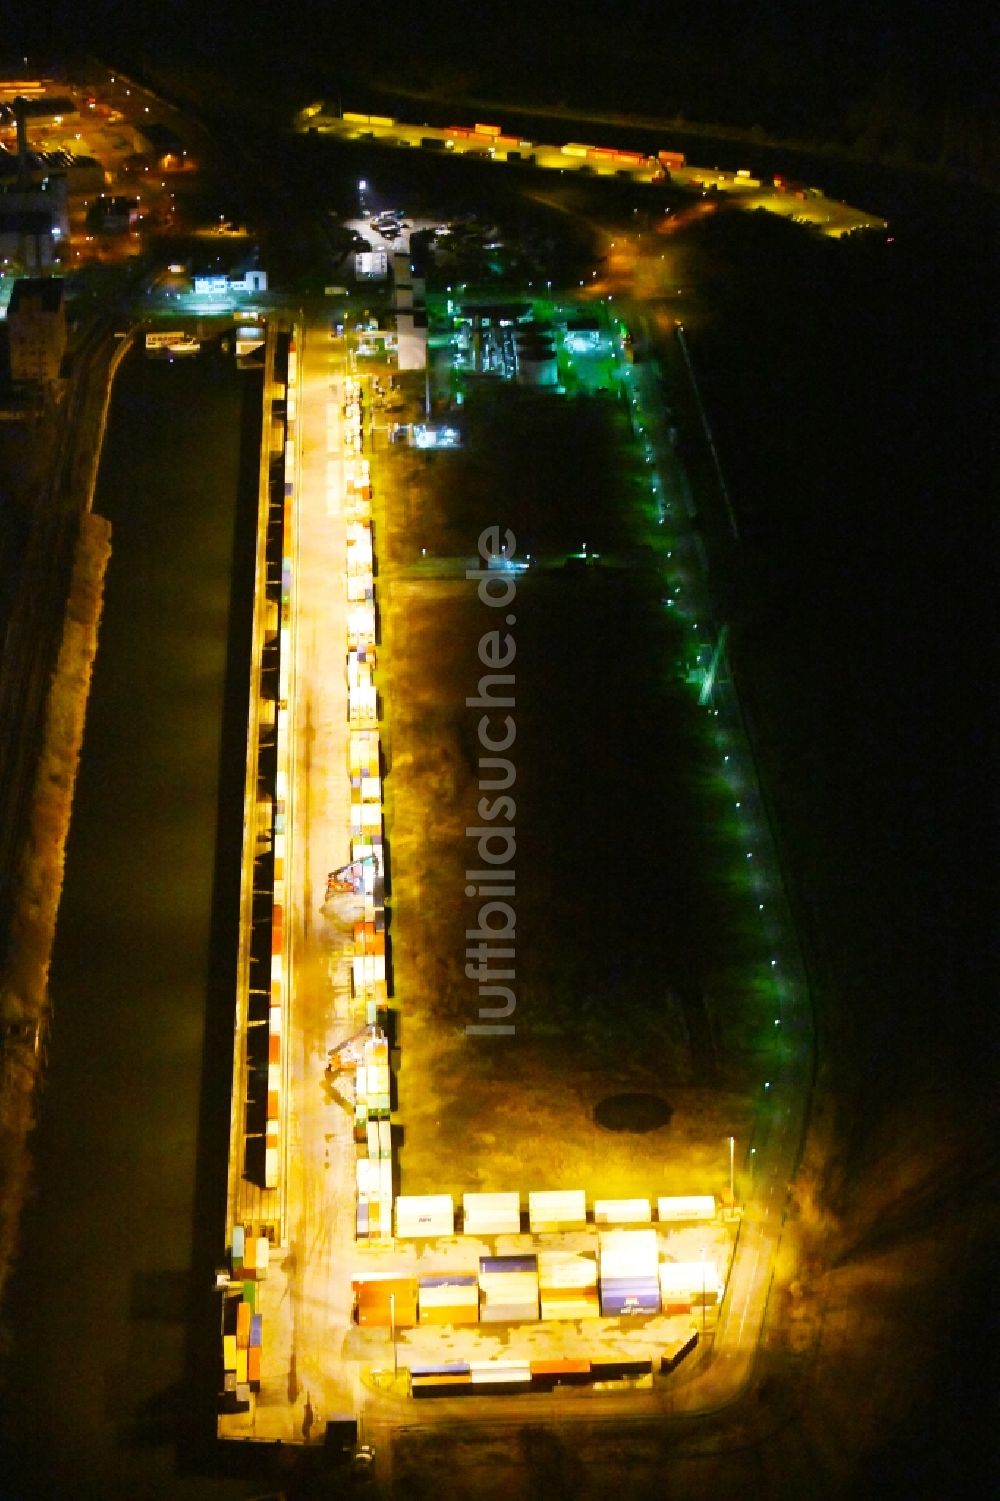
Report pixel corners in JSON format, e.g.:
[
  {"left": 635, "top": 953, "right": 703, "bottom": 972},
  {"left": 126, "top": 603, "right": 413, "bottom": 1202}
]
[{"left": 396, "top": 1189, "right": 716, "bottom": 1240}]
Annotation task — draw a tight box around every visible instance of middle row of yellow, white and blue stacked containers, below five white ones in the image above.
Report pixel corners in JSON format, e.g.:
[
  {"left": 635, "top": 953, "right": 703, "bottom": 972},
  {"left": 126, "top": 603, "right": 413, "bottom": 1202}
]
[{"left": 351, "top": 1229, "right": 724, "bottom": 1330}]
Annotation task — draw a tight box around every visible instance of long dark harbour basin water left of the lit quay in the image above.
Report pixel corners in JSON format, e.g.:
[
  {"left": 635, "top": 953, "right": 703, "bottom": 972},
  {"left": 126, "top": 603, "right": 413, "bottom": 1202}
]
[{"left": 0, "top": 353, "right": 260, "bottom": 1501}]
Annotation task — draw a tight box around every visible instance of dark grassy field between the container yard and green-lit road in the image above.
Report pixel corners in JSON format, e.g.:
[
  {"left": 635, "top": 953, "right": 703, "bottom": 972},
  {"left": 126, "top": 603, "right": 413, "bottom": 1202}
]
[{"left": 380, "top": 303, "right": 782, "bottom": 1196}]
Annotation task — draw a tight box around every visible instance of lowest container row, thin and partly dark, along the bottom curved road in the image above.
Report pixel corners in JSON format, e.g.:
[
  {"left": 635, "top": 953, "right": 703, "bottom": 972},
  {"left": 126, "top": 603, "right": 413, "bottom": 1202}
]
[{"left": 410, "top": 1330, "right": 698, "bottom": 1397}]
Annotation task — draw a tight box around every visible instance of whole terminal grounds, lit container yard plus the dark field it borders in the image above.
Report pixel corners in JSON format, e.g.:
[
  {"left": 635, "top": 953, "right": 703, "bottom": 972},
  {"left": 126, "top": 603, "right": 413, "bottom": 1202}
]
[{"left": 219, "top": 283, "right": 772, "bottom": 1436}]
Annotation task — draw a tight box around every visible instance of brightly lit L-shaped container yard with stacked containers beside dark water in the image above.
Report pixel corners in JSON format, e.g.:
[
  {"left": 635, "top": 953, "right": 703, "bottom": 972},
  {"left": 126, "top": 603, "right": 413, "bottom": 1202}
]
[{"left": 211, "top": 279, "right": 805, "bottom": 1441}]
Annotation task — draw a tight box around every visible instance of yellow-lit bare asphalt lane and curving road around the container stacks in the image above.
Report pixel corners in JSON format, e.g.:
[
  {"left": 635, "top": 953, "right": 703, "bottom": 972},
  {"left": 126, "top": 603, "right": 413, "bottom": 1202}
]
[{"left": 221, "top": 283, "right": 806, "bottom": 1450}]
